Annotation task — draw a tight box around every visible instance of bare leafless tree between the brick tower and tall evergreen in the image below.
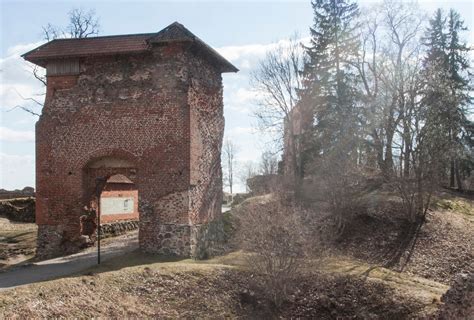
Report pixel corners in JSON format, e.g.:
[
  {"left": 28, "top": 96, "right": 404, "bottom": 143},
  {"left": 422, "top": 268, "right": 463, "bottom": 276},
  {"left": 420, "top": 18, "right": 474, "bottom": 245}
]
[{"left": 251, "top": 37, "right": 305, "bottom": 188}]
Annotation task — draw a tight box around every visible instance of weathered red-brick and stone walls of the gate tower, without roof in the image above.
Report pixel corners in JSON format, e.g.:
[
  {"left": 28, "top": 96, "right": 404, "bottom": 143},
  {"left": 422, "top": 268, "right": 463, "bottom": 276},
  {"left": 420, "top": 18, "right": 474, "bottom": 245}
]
[{"left": 36, "top": 43, "right": 228, "bottom": 256}]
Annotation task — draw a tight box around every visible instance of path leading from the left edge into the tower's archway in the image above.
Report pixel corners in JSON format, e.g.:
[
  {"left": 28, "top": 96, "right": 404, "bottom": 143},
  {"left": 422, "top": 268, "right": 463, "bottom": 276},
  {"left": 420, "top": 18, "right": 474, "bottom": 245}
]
[{"left": 0, "top": 231, "right": 138, "bottom": 291}]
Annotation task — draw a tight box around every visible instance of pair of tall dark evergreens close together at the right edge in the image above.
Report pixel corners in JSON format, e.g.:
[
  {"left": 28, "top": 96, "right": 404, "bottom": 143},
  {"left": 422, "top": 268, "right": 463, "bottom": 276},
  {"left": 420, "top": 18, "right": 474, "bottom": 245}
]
[{"left": 423, "top": 9, "right": 472, "bottom": 189}]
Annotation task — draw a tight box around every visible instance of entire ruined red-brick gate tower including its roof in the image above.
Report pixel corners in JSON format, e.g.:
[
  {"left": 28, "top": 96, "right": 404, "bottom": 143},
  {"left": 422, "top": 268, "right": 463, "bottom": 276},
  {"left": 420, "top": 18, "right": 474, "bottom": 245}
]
[{"left": 23, "top": 22, "right": 238, "bottom": 258}]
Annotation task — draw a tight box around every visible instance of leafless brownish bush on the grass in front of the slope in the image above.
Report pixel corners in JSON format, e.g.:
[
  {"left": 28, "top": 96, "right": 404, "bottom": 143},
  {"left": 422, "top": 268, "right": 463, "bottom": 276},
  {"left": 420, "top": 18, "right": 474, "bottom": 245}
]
[{"left": 236, "top": 200, "right": 306, "bottom": 307}]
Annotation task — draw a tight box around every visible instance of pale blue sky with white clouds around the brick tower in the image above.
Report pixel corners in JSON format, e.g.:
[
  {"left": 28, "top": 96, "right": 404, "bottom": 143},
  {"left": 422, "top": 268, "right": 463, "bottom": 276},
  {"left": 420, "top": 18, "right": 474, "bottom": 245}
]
[{"left": 0, "top": 0, "right": 474, "bottom": 191}]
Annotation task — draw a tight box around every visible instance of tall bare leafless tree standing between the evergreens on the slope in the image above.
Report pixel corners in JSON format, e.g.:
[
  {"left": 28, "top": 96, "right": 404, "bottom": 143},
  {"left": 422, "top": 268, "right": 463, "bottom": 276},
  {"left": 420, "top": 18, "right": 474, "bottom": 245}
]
[{"left": 356, "top": 0, "right": 425, "bottom": 178}]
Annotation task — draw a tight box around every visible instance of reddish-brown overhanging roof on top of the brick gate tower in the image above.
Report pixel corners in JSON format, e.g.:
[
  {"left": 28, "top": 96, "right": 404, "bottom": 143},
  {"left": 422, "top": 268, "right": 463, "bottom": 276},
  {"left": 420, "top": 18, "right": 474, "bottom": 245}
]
[{"left": 22, "top": 22, "right": 238, "bottom": 72}]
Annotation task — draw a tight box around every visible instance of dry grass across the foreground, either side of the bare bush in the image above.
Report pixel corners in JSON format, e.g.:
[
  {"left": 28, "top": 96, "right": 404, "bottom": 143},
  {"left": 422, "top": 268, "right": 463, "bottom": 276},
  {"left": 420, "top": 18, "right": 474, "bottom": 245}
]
[{"left": 0, "top": 252, "right": 444, "bottom": 319}]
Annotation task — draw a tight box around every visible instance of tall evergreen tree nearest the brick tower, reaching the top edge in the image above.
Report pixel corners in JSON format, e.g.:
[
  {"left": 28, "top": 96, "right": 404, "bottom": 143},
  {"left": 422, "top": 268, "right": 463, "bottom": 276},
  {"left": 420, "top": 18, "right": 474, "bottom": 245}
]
[{"left": 304, "top": 0, "right": 359, "bottom": 157}]
